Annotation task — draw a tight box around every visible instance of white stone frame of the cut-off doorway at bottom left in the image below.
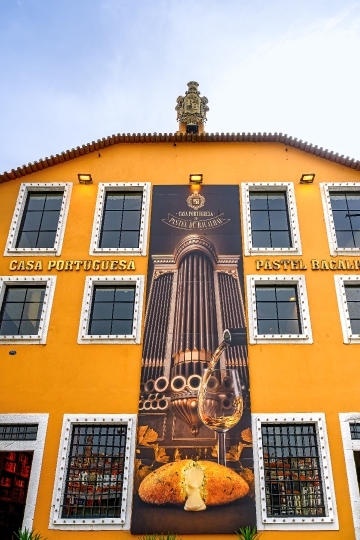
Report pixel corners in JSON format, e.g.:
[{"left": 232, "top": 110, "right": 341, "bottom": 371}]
[{"left": 0, "top": 414, "right": 49, "bottom": 530}]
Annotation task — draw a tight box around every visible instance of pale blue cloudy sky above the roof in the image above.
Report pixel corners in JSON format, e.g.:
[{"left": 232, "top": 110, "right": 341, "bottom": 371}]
[{"left": 0, "top": 0, "right": 360, "bottom": 172}]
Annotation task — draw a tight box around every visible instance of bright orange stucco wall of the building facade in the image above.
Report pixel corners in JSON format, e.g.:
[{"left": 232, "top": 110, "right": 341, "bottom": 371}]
[{"left": 0, "top": 143, "right": 360, "bottom": 540}]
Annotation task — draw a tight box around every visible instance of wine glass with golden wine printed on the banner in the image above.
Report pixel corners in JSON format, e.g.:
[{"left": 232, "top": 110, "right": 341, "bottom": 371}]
[{"left": 198, "top": 369, "right": 244, "bottom": 466}]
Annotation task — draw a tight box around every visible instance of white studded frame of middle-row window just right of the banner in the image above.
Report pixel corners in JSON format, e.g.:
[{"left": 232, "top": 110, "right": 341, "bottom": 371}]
[{"left": 246, "top": 274, "right": 313, "bottom": 345}]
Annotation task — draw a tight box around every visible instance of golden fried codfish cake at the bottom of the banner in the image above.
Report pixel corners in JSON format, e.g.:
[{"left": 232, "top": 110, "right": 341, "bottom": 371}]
[{"left": 139, "top": 459, "right": 249, "bottom": 506}]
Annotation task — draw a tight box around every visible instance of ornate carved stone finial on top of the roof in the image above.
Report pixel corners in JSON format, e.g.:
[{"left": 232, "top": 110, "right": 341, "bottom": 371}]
[{"left": 175, "top": 81, "right": 209, "bottom": 133}]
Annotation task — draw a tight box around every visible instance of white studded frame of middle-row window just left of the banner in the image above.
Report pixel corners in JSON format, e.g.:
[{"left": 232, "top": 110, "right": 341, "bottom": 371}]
[{"left": 78, "top": 275, "right": 144, "bottom": 345}]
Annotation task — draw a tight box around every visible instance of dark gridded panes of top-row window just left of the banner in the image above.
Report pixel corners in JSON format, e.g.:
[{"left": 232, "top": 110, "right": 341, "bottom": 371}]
[{"left": 99, "top": 191, "right": 143, "bottom": 249}]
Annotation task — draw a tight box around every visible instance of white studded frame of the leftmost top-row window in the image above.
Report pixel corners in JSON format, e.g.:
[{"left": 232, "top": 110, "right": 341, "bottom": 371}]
[{"left": 4, "top": 182, "right": 72, "bottom": 257}]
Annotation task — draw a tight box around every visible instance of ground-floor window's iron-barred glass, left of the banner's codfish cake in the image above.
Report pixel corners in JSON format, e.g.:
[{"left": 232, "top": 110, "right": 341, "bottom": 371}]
[{"left": 60, "top": 424, "right": 127, "bottom": 519}]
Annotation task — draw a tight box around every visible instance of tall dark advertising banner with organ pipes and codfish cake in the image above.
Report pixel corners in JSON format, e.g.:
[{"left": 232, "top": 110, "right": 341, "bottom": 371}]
[{"left": 131, "top": 185, "right": 256, "bottom": 534}]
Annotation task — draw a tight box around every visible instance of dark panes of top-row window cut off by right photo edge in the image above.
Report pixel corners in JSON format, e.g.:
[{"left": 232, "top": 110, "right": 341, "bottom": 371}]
[{"left": 330, "top": 191, "right": 360, "bottom": 248}]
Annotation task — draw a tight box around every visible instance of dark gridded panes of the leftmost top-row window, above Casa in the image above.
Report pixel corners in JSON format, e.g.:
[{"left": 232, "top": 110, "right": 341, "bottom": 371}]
[{"left": 16, "top": 191, "right": 64, "bottom": 249}]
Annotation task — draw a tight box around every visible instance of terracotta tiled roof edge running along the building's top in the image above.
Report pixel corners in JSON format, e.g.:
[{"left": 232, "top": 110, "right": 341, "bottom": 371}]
[{"left": 0, "top": 133, "right": 360, "bottom": 183}]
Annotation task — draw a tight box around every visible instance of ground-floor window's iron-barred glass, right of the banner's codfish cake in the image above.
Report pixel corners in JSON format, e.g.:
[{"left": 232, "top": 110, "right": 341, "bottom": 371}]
[{"left": 261, "top": 423, "right": 326, "bottom": 517}]
